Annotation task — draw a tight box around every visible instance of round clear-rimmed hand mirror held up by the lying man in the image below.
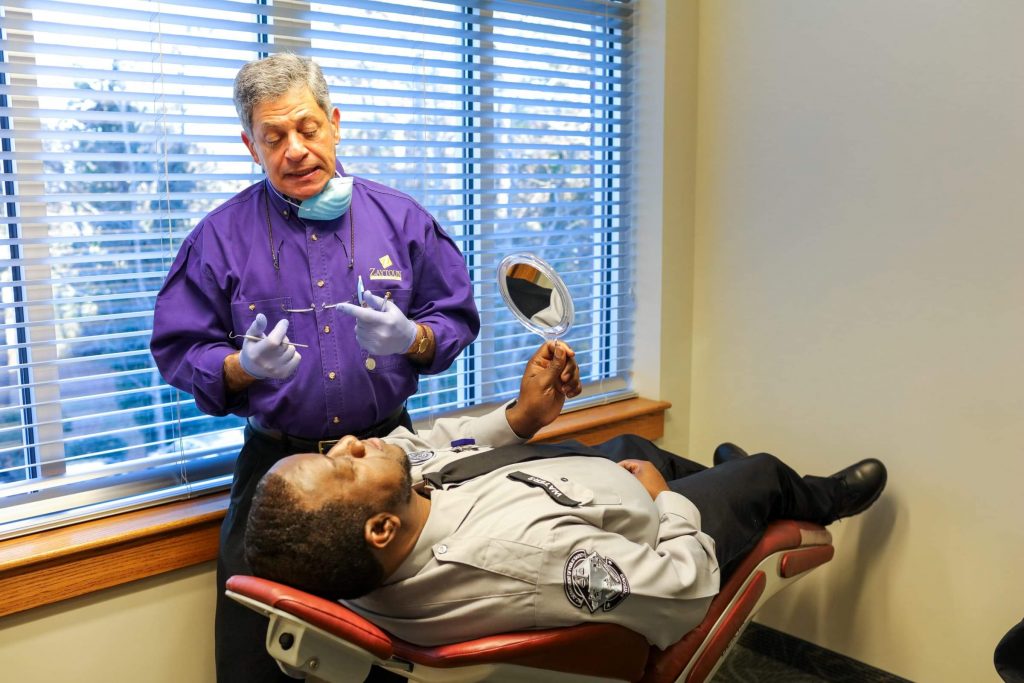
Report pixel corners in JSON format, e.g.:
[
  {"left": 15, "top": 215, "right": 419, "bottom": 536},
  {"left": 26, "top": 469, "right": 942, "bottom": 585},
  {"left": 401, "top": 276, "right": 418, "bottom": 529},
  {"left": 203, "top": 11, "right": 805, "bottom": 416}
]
[{"left": 498, "top": 254, "right": 573, "bottom": 340}]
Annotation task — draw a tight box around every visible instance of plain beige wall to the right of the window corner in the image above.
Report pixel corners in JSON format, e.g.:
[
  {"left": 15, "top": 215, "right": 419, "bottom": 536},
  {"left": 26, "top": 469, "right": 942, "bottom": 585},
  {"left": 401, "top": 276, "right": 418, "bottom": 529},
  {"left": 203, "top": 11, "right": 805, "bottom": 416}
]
[{"left": 684, "top": 0, "right": 1024, "bottom": 682}]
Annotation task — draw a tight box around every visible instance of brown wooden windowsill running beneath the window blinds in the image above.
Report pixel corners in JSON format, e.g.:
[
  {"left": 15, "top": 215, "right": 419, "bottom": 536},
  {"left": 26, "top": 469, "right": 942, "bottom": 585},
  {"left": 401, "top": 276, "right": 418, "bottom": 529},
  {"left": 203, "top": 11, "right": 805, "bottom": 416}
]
[{"left": 0, "top": 398, "right": 671, "bottom": 616}]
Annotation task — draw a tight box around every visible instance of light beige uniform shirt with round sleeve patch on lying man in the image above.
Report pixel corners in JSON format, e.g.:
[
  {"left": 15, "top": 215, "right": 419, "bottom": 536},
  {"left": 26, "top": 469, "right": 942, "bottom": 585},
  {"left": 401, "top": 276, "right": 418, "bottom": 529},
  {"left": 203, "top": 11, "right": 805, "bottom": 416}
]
[{"left": 348, "top": 411, "right": 719, "bottom": 648}]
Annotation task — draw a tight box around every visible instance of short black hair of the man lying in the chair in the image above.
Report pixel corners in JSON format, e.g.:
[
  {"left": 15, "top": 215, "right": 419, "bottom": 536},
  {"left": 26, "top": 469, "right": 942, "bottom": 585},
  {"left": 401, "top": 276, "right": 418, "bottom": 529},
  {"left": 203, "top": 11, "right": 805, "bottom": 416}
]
[{"left": 245, "top": 472, "right": 384, "bottom": 600}]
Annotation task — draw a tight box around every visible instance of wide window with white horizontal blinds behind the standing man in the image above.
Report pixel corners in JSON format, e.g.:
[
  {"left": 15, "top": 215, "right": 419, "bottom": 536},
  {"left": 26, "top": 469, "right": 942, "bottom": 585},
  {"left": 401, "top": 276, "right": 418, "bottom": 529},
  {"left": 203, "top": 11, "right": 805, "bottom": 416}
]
[{"left": 0, "top": 0, "right": 632, "bottom": 538}]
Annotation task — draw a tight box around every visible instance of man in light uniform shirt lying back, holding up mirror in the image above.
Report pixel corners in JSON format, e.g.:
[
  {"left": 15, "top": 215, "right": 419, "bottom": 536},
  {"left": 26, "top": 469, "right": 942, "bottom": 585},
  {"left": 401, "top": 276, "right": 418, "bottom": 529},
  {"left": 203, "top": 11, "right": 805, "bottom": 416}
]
[{"left": 246, "top": 342, "right": 886, "bottom": 648}]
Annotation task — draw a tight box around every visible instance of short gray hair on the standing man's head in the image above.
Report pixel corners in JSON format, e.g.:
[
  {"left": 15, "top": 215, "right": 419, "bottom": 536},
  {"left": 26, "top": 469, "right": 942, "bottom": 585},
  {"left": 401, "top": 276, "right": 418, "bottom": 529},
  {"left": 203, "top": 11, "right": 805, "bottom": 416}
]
[{"left": 234, "top": 52, "right": 332, "bottom": 137}]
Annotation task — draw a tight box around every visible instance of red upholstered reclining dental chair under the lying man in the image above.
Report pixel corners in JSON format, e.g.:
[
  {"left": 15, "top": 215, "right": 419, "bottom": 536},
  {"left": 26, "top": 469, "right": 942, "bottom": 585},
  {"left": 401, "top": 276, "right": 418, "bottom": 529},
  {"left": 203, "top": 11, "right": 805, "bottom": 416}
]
[{"left": 227, "top": 521, "right": 835, "bottom": 683}]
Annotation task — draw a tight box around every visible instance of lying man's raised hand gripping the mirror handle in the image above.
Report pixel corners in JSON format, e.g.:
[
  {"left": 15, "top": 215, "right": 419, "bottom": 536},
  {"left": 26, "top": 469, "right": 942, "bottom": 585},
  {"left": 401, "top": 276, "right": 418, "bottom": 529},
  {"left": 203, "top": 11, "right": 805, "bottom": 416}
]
[{"left": 506, "top": 341, "right": 582, "bottom": 438}]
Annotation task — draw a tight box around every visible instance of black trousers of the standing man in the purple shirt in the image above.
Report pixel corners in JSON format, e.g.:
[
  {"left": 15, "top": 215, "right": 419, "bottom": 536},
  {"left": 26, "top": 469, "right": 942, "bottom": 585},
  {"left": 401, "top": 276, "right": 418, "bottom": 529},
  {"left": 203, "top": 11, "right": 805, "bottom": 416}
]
[{"left": 214, "top": 411, "right": 413, "bottom": 683}]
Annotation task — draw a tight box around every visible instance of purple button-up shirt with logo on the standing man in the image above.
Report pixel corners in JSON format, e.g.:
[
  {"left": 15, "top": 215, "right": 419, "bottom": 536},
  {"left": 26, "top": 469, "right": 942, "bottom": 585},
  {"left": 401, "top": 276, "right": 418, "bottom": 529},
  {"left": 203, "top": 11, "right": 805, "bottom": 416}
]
[{"left": 151, "top": 164, "right": 480, "bottom": 439}]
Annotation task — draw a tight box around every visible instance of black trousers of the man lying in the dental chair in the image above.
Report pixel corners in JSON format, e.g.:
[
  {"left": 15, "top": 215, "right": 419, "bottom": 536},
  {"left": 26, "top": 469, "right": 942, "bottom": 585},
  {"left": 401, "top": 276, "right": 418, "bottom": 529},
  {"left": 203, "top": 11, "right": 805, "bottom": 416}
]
[{"left": 569, "top": 435, "right": 842, "bottom": 583}]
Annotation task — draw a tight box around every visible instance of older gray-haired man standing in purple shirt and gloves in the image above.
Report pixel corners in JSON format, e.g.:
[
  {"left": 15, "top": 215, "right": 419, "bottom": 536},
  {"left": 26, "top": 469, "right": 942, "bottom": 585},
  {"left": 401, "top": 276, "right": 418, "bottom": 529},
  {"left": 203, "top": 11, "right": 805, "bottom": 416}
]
[{"left": 151, "top": 53, "right": 480, "bottom": 683}]
